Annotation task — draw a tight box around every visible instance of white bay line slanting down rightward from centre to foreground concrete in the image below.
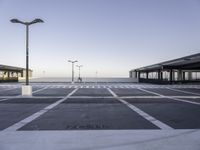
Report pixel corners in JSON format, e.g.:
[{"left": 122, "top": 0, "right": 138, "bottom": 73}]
[{"left": 108, "top": 88, "right": 173, "bottom": 130}]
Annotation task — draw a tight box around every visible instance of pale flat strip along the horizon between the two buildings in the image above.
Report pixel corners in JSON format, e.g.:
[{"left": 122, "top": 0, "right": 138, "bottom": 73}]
[{"left": 19, "top": 77, "right": 137, "bottom": 83}]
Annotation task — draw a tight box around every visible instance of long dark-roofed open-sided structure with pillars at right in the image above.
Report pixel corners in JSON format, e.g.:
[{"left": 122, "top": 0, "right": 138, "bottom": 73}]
[{"left": 129, "top": 53, "right": 200, "bottom": 84}]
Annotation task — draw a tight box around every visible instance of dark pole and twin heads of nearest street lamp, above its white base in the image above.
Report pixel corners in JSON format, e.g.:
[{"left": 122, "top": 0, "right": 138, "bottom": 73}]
[{"left": 10, "top": 18, "right": 44, "bottom": 95}]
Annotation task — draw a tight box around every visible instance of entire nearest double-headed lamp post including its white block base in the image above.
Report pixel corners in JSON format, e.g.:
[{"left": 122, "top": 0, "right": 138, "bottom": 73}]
[{"left": 10, "top": 18, "right": 44, "bottom": 95}]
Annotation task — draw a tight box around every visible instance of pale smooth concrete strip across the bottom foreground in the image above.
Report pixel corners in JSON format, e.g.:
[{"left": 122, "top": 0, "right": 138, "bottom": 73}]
[{"left": 0, "top": 130, "right": 200, "bottom": 150}]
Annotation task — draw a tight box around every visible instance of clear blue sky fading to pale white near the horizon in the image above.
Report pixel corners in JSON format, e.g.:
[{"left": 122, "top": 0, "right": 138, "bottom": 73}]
[{"left": 0, "top": 0, "right": 200, "bottom": 77}]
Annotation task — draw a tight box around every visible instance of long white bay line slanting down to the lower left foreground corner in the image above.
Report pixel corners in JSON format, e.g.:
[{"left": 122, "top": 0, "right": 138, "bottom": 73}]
[{"left": 3, "top": 88, "right": 78, "bottom": 132}]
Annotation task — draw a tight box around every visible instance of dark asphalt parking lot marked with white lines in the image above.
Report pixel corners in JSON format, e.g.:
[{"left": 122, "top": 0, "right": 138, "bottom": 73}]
[{"left": 0, "top": 83, "right": 200, "bottom": 148}]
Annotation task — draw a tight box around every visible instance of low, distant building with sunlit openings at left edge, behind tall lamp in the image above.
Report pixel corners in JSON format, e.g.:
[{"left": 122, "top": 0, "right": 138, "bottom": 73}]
[{"left": 0, "top": 65, "right": 33, "bottom": 82}]
